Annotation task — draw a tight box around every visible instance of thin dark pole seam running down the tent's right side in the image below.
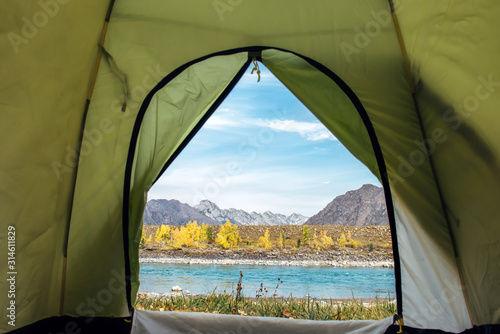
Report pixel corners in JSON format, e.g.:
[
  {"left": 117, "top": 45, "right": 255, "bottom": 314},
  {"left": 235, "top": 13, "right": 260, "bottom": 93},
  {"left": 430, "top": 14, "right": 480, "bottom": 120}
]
[{"left": 389, "top": 0, "right": 475, "bottom": 325}]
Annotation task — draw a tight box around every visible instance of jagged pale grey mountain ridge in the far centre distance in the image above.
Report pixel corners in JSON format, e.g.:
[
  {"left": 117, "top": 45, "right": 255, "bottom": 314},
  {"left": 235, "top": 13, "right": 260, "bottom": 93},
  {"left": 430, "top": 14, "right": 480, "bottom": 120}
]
[{"left": 194, "top": 200, "right": 307, "bottom": 225}]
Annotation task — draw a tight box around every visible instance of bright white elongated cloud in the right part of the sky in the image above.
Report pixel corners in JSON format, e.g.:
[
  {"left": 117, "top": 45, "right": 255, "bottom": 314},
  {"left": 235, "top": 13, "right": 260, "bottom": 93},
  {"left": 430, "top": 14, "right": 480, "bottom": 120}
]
[{"left": 259, "top": 119, "right": 337, "bottom": 141}]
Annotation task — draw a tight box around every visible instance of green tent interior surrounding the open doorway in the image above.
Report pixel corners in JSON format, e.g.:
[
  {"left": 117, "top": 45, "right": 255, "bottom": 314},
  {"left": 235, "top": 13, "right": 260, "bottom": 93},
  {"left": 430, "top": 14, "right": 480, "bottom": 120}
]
[{"left": 0, "top": 0, "right": 500, "bottom": 333}]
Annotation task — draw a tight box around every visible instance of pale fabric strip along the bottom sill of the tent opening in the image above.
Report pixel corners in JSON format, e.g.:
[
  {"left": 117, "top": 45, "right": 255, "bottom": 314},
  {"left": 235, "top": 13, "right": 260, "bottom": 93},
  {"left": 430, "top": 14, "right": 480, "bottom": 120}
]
[{"left": 131, "top": 310, "right": 393, "bottom": 334}]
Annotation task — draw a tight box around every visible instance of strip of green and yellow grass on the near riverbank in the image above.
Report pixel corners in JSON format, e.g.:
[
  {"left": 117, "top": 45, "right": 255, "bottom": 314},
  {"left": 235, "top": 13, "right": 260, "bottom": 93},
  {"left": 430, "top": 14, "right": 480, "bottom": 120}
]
[{"left": 135, "top": 291, "right": 396, "bottom": 320}]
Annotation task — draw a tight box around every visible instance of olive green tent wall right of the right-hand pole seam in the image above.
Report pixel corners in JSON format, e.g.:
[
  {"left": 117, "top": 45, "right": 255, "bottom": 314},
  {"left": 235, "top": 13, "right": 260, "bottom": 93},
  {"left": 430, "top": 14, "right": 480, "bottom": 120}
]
[{"left": 399, "top": 1, "right": 500, "bottom": 324}]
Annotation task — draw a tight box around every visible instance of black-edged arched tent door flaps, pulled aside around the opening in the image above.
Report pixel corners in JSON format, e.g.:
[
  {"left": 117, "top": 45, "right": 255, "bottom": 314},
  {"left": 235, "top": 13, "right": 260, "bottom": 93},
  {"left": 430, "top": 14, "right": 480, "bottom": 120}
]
[{"left": 124, "top": 48, "right": 402, "bottom": 313}]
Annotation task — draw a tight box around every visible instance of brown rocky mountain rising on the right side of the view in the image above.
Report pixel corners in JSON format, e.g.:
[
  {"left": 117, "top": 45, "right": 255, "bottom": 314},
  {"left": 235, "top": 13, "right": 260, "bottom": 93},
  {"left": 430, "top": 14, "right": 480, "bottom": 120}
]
[{"left": 305, "top": 184, "right": 389, "bottom": 226}]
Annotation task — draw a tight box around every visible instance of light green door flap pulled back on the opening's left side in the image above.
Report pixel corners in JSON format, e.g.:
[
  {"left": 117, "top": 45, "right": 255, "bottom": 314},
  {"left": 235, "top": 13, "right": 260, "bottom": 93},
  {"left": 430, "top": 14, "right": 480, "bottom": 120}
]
[{"left": 129, "top": 52, "right": 248, "bottom": 296}]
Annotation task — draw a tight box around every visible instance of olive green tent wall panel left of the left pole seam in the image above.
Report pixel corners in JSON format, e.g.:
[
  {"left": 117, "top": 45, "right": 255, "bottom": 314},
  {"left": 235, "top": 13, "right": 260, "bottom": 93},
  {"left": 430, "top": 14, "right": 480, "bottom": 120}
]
[{"left": 0, "top": 1, "right": 107, "bottom": 331}]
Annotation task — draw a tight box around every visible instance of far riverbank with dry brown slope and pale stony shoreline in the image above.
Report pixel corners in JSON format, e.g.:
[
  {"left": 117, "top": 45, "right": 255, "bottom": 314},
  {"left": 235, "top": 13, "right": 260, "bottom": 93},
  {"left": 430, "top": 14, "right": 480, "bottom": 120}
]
[{"left": 139, "top": 225, "right": 394, "bottom": 268}]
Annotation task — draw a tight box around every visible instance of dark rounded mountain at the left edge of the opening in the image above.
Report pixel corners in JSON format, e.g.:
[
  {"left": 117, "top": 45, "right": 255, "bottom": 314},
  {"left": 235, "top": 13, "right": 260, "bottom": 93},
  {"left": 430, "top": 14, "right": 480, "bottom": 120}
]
[{"left": 144, "top": 199, "right": 219, "bottom": 225}]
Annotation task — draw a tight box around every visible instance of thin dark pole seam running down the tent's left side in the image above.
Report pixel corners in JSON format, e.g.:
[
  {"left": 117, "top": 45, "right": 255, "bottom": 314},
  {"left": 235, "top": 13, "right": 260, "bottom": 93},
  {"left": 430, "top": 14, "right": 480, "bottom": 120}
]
[{"left": 59, "top": 0, "right": 115, "bottom": 316}]
